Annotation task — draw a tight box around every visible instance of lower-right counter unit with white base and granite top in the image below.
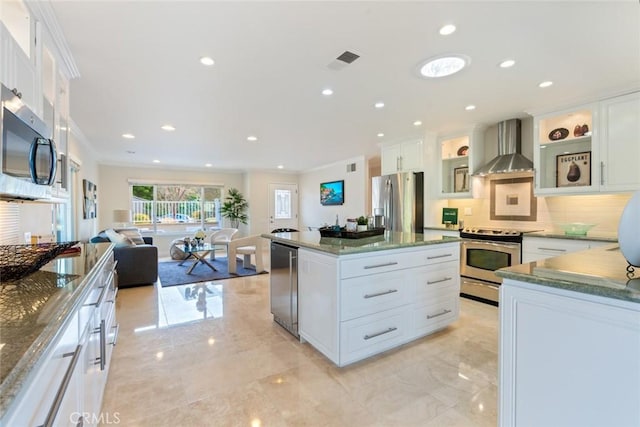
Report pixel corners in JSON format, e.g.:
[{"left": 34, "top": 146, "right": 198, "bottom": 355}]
[{"left": 497, "top": 245, "right": 640, "bottom": 426}]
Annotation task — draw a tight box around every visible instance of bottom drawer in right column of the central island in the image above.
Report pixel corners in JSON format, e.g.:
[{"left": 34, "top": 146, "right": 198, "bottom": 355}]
[{"left": 412, "top": 291, "right": 460, "bottom": 336}]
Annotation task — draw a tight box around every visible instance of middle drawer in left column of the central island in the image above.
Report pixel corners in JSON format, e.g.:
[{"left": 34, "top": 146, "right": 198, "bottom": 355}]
[{"left": 340, "top": 270, "right": 414, "bottom": 320}]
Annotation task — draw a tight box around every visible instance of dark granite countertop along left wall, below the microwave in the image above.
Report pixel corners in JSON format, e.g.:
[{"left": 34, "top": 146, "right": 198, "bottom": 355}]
[{"left": 0, "top": 243, "right": 112, "bottom": 419}]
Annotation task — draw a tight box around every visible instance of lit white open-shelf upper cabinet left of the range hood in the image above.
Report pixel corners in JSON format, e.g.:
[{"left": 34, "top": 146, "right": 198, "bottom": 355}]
[{"left": 438, "top": 126, "right": 484, "bottom": 199}]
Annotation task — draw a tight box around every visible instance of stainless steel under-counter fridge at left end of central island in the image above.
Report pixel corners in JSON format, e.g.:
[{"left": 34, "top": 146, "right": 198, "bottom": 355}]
[{"left": 270, "top": 242, "right": 299, "bottom": 338}]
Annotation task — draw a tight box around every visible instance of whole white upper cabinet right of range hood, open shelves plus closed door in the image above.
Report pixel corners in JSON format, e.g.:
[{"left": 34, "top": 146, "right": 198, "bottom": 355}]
[{"left": 533, "top": 92, "right": 640, "bottom": 196}]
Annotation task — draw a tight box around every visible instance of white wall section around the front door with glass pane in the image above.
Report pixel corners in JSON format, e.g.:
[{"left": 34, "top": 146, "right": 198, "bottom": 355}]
[{"left": 245, "top": 171, "right": 301, "bottom": 234}]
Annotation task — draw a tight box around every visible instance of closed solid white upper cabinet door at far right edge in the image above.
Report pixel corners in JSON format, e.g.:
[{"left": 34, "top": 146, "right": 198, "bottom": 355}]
[{"left": 600, "top": 92, "right": 640, "bottom": 191}]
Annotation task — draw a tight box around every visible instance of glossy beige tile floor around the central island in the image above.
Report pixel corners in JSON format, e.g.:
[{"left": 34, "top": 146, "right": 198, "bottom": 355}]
[{"left": 102, "top": 274, "right": 498, "bottom": 427}]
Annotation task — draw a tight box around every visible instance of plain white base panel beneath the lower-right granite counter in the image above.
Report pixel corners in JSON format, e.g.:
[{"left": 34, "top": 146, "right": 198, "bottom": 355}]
[{"left": 499, "top": 280, "right": 640, "bottom": 427}]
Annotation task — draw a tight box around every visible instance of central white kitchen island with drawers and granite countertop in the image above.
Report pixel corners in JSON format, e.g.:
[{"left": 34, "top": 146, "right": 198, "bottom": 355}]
[{"left": 262, "top": 231, "right": 460, "bottom": 366}]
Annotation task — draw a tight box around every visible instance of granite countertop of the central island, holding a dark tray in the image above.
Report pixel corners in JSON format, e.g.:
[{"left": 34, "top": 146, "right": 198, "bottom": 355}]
[{"left": 262, "top": 231, "right": 460, "bottom": 255}]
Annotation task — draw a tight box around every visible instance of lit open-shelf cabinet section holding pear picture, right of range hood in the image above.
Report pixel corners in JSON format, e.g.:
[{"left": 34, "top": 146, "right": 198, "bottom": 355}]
[{"left": 533, "top": 104, "right": 600, "bottom": 194}]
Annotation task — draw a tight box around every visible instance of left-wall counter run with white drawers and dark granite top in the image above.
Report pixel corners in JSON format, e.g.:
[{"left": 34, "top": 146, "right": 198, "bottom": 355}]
[{"left": 0, "top": 243, "right": 117, "bottom": 426}]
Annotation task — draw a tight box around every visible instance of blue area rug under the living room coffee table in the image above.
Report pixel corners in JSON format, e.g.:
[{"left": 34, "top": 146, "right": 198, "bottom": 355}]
[{"left": 158, "top": 258, "right": 266, "bottom": 288}]
